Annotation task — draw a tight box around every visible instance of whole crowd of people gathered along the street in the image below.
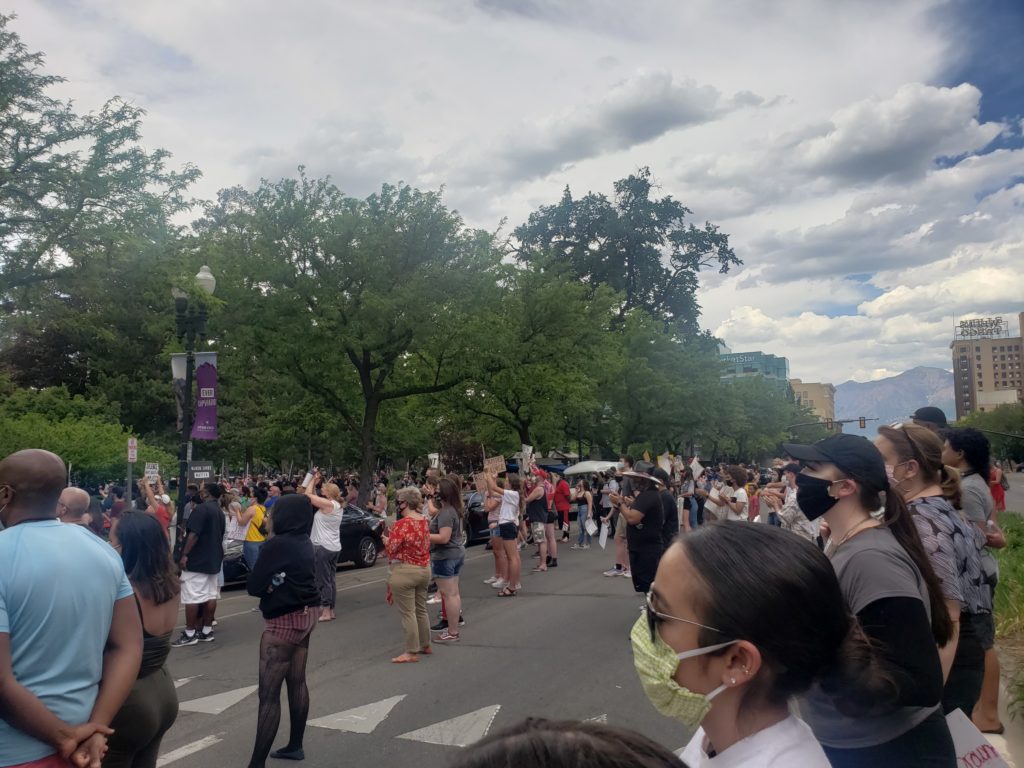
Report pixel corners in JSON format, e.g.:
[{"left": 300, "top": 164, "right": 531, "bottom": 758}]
[{"left": 0, "top": 409, "right": 1006, "bottom": 768}]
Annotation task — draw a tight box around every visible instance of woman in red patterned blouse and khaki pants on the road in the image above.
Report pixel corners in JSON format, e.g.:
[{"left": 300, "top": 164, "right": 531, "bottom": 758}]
[{"left": 384, "top": 487, "right": 433, "bottom": 664}]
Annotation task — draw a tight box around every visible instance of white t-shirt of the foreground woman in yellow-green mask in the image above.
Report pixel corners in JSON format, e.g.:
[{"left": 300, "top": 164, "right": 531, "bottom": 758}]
[{"left": 679, "top": 715, "right": 829, "bottom": 768}]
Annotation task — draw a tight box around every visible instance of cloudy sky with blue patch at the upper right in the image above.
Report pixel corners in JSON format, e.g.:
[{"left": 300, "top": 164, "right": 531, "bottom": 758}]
[{"left": 14, "top": 0, "right": 1024, "bottom": 384}]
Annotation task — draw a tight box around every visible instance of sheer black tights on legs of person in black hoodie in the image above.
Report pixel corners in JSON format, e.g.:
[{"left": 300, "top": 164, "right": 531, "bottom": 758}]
[{"left": 249, "top": 632, "right": 309, "bottom": 768}]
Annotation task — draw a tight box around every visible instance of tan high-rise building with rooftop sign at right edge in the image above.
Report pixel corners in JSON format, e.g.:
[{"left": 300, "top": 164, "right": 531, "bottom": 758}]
[{"left": 949, "top": 312, "right": 1024, "bottom": 419}]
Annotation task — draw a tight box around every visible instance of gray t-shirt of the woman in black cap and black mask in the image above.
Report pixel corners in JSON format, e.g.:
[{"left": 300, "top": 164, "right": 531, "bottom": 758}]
[{"left": 799, "top": 528, "right": 939, "bottom": 750}]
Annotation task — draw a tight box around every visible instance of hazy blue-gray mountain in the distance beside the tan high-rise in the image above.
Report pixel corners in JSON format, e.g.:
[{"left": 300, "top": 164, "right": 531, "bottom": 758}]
[{"left": 836, "top": 367, "right": 956, "bottom": 437}]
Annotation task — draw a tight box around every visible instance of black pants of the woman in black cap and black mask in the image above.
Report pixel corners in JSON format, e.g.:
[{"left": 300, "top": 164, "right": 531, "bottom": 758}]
[{"left": 822, "top": 710, "right": 956, "bottom": 768}]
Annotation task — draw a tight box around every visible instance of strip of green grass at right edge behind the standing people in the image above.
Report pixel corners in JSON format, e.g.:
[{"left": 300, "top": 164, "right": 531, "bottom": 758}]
[{"left": 994, "top": 512, "right": 1024, "bottom": 715}]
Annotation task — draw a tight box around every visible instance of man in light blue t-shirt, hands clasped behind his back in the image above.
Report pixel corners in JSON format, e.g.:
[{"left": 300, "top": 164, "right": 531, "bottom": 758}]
[{"left": 0, "top": 451, "right": 142, "bottom": 768}]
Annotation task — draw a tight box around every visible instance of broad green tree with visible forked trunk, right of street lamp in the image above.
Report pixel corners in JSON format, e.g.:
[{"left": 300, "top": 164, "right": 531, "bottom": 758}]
[{"left": 197, "top": 174, "right": 500, "bottom": 499}]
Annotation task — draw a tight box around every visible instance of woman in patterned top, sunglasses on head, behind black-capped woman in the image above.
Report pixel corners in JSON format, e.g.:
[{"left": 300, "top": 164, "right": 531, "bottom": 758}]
[{"left": 874, "top": 423, "right": 992, "bottom": 717}]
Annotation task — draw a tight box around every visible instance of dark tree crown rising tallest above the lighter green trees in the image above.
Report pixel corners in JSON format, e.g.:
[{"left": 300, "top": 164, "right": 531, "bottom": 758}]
[{"left": 514, "top": 168, "right": 741, "bottom": 335}]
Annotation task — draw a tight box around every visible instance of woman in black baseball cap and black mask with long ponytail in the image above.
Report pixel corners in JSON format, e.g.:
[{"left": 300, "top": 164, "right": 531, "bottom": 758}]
[{"left": 783, "top": 434, "right": 956, "bottom": 768}]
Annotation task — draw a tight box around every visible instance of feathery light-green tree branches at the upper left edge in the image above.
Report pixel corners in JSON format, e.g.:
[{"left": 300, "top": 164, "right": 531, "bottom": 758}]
[{"left": 0, "top": 15, "right": 199, "bottom": 313}]
